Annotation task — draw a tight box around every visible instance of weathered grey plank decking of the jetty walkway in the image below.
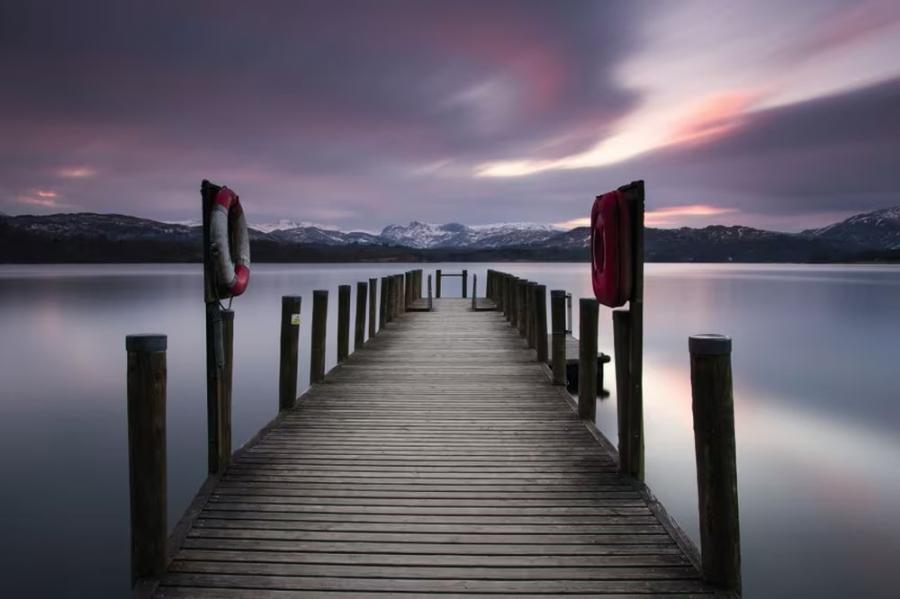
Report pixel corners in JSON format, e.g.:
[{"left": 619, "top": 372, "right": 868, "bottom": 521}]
[{"left": 157, "top": 299, "right": 710, "bottom": 598}]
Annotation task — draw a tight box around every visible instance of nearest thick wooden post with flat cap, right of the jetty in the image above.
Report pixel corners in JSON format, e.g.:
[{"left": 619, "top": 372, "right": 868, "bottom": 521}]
[{"left": 688, "top": 335, "right": 741, "bottom": 593}]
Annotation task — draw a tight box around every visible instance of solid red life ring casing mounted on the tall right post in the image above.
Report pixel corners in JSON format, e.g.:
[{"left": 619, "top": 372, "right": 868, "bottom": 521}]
[{"left": 591, "top": 191, "right": 632, "bottom": 308}]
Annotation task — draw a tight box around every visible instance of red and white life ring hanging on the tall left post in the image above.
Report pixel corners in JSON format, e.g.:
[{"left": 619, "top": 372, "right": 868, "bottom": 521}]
[{"left": 209, "top": 187, "right": 250, "bottom": 297}]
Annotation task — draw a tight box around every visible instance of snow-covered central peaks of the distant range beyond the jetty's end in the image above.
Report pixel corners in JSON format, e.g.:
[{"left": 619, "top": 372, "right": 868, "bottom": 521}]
[{"left": 381, "top": 221, "right": 560, "bottom": 249}]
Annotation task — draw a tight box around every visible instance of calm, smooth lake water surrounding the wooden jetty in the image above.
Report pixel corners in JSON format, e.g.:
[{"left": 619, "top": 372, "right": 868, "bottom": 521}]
[{"left": 0, "top": 264, "right": 900, "bottom": 597}]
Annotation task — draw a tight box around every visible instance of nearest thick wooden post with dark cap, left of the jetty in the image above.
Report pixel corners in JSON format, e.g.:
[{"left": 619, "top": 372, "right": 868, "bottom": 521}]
[{"left": 125, "top": 335, "right": 169, "bottom": 587}]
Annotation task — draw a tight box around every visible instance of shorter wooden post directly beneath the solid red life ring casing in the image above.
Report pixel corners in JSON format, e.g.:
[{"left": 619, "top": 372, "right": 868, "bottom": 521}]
[{"left": 613, "top": 310, "right": 644, "bottom": 480}]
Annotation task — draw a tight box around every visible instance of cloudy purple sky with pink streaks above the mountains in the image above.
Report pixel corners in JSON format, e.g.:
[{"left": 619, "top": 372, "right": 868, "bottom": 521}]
[{"left": 0, "top": 0, "right": 900, "bottom": 231}]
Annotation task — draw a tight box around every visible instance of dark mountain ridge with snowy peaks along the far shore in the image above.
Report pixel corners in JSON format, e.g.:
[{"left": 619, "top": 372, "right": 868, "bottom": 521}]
[{"left": 0, "top": 207, "right": 900, "bottom": 263}]
